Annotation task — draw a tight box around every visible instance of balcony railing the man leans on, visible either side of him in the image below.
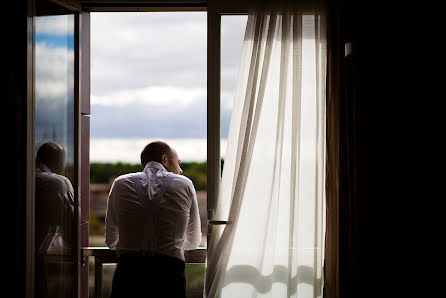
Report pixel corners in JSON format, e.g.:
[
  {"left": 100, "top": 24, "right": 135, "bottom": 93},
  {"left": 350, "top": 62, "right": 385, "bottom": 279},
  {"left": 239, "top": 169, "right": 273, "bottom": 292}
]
[{"left": 82, "top": 247, "right": 206, "bottom": 298}]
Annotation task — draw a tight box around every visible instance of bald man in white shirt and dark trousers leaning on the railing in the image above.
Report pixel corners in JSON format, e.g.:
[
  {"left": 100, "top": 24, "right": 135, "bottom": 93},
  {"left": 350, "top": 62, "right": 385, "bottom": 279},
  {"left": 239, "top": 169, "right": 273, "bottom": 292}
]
[{"left": 105, "top": 141, "right": 201, "bottom": 298}]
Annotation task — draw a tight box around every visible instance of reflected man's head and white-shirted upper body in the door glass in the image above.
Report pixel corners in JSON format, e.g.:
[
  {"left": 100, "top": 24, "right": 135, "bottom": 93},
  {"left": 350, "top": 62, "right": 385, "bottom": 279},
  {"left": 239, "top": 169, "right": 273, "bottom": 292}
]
[{"left": 35, "top": 142, "right": 74, "bottom": 255}]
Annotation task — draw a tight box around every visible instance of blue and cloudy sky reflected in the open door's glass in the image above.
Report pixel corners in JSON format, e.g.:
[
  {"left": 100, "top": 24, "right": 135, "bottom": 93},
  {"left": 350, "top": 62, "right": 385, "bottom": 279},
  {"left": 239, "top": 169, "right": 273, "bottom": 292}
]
[{"left": 35, "top": 15, "right": 74, "bottom": 162}]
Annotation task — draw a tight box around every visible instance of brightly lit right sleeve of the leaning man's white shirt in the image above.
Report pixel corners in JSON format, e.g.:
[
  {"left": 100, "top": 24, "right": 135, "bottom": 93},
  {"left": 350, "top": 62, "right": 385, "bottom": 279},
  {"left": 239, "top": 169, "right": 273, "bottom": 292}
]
[{"left": 183, "top": 186, "right": 201, "bottom": 250}]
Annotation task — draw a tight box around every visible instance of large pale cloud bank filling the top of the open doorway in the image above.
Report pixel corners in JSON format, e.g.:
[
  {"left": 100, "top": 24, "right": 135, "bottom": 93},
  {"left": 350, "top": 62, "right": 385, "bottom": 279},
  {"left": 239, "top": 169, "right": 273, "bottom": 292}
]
[{"left": 91, "top": 12, "right": 207, "bottom": 96}]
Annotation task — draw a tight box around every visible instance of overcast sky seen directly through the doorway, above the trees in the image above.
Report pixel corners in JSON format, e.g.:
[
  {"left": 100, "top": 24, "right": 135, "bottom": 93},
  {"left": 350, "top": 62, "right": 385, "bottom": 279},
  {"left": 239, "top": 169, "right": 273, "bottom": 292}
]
[{"left": 91, "top": 12, "right": 247, "bottom": 161}]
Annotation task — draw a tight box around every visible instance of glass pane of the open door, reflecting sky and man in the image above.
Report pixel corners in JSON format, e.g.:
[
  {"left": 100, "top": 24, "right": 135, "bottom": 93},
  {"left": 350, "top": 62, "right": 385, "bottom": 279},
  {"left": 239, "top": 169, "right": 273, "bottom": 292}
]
[{"left": 35, "top": 15, "right": 77, "bottom": 297}]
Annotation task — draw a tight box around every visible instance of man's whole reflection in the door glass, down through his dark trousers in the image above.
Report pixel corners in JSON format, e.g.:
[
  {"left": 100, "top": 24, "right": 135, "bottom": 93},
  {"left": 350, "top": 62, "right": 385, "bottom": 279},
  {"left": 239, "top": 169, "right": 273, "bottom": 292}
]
[{"left": 35, "top": 142, "right": 75, "bottom": 298}]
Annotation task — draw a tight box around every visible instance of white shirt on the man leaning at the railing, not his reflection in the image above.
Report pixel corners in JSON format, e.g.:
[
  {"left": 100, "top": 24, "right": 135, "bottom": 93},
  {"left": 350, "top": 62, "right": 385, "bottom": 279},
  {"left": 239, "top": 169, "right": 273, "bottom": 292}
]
[{"left": 105, "top": 162, "right": 201, "bottom": 261}]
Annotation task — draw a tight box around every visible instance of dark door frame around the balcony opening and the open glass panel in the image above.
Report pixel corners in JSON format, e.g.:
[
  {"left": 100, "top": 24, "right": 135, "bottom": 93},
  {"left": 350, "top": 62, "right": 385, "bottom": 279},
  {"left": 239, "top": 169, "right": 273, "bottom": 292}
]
[{"left": 26, "top": 0, "right": 254, "bottom": 297}]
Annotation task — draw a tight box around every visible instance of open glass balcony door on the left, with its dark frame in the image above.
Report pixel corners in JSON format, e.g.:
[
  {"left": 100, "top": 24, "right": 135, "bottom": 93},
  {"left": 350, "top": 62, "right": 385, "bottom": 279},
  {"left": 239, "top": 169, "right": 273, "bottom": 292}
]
[{"left": 33, "top": 0, "right": 90, "bottom": 298}]
